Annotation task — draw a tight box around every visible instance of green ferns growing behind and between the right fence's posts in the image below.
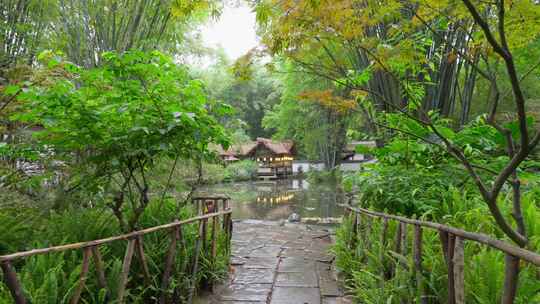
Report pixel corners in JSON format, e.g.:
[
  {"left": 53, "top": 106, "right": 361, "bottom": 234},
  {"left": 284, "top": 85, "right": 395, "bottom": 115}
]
[{"left": 332, "top": 210, "right": 540, "bottom": 304}]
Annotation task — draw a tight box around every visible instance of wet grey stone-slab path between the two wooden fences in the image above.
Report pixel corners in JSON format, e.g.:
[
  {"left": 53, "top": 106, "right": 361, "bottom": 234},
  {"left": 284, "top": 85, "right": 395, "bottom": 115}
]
[{"left": 201, "top": 220, "right": 351, "bottom": 304}]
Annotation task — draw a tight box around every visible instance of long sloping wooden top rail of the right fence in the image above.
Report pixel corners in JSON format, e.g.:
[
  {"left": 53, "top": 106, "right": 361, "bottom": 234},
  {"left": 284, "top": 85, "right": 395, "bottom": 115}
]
[{"left": 341, "top": 204, "right": 540, "bottom": 266}]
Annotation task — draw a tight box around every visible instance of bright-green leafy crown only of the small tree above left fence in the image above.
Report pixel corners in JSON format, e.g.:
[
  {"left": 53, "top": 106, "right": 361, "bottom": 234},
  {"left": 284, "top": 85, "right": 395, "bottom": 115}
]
[{"left": 16, "top": 51, "right": 226, "bottom": 163}]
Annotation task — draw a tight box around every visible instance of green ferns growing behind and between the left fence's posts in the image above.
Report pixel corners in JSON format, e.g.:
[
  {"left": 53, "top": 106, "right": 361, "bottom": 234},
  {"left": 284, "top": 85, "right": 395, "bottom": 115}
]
[{"left": 0, "top": 200, "right": 229, "bottom": 304}]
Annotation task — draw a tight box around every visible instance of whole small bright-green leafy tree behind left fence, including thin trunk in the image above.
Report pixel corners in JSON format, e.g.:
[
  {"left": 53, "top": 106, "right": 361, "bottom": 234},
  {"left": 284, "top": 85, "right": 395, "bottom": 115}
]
[{"left": 14, "top": 51, "right": 228, "bottom": 230}]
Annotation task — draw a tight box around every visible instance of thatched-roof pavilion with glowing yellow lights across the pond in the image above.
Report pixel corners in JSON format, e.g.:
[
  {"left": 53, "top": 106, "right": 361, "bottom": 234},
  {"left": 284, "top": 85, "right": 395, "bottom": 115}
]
[{"left": 219, "top": 137, "right": 295, "bottom": 179}]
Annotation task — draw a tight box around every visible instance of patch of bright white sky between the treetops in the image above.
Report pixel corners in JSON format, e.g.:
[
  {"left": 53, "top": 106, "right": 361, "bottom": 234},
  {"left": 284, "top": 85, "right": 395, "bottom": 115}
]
[{"left": 201, "top": 5, "right": 258, "bottom": 60}]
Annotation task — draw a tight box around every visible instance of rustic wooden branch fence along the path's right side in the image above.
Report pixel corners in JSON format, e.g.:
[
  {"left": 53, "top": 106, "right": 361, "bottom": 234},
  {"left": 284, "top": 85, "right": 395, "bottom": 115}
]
[{"left": 342, "top": 204, "right": 540, "bottom": 304}]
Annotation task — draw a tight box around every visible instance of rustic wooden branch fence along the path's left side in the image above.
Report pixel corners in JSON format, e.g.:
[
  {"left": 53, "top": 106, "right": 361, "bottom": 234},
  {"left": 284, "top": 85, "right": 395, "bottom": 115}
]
[{"left": 0, "top": 197, "right": 232, "bottom": 304}]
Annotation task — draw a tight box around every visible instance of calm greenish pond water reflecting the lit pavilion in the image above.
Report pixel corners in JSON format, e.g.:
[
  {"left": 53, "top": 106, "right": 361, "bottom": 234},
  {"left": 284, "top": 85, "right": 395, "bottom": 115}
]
[{"left": 201, "top": 179, "right": 343, "bottom": 222}]
